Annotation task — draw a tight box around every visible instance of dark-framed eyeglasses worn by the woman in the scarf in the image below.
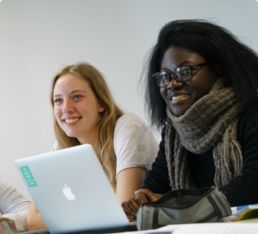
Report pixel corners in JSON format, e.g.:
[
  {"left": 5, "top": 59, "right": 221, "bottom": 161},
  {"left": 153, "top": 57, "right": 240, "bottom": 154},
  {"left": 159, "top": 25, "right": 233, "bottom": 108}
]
[{"left": 152, "top": 63, "right": 209, "bottom": 87}]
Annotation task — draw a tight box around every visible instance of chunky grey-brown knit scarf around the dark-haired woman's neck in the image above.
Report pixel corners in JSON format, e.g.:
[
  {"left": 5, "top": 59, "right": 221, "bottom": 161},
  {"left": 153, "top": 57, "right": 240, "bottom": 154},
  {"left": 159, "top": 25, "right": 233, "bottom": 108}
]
[{"left": 165, "top": 80, "right": 243, "bottom": 190}]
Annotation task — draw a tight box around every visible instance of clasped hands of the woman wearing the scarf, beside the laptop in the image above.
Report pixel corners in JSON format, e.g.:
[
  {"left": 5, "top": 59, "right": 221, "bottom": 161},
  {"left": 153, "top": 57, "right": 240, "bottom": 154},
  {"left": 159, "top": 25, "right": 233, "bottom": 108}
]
[{"left": 122, "top": 189, "right": 161, "bottom": 221}]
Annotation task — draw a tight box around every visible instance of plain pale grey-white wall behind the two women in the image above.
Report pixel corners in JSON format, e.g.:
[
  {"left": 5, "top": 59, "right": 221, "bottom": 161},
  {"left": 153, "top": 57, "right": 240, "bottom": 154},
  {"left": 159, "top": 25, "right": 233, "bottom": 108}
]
[{"left": 0, "top": 0, "right": 258, "bottom": 196}]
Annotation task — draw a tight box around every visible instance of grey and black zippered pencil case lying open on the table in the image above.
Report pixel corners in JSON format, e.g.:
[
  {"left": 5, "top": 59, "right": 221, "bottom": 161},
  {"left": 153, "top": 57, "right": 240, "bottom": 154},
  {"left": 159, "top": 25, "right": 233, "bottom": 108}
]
[{"left": 136, "top": 187, "right": 231, "bottom": 230}]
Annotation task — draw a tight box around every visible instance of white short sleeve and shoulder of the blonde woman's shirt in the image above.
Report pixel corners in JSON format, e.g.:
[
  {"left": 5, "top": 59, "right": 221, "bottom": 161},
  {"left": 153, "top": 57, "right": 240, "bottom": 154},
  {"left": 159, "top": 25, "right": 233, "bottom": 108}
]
[{"left": 114, "top": 113, "right": 158, "bottom": 175}]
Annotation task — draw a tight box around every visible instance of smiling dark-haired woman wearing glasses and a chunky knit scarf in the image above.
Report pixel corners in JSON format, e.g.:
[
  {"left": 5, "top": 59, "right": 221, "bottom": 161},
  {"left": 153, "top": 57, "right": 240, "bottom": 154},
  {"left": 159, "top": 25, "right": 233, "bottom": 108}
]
[{"left": 123, "top": 20, "right": 258, "bottom": 220}]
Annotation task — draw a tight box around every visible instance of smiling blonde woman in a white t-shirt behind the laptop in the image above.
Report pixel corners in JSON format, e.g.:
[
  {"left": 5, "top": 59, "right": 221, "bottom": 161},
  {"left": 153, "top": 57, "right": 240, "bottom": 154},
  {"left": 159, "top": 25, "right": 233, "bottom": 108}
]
[{"left": 28, "top": 63, "right": 157, "bottom": 229}]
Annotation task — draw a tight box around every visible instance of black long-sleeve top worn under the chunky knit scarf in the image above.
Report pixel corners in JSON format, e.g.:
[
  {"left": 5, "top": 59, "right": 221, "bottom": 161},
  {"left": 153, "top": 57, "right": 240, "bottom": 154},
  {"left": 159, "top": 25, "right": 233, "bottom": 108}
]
[{"left": 144, "top": 106, "right": 258, "bottom": 206}]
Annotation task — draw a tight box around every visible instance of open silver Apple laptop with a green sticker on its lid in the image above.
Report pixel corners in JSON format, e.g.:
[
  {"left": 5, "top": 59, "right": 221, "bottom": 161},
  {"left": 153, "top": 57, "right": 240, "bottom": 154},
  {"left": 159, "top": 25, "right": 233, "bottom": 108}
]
[{"left": 15, "top": 144, "right": 129, "bottom": 233}]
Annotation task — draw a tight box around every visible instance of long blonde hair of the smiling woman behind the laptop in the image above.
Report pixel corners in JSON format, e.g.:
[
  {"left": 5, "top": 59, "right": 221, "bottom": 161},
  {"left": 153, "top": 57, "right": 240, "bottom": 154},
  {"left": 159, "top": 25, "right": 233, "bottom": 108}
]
[{"left": 50, "top": 63, "right": 123, "bottom": 190}]
